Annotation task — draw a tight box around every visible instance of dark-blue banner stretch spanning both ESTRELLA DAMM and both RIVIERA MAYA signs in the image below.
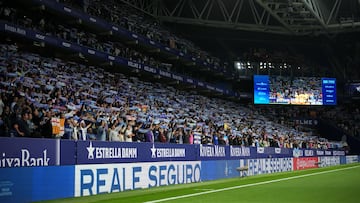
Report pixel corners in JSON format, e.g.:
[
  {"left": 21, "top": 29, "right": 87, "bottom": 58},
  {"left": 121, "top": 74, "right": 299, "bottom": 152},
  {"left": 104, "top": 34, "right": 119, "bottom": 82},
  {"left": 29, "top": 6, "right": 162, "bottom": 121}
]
[{"left": 77, "top": 141, "right": 256, "bottom": 164}]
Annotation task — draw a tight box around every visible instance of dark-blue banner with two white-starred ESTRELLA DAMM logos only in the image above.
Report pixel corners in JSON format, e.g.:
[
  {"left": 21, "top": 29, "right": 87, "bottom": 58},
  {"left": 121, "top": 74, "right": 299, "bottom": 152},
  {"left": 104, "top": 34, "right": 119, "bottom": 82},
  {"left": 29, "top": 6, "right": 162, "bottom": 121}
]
[{"left": 77, "top": 141, "right": 197, "bottom": 164}]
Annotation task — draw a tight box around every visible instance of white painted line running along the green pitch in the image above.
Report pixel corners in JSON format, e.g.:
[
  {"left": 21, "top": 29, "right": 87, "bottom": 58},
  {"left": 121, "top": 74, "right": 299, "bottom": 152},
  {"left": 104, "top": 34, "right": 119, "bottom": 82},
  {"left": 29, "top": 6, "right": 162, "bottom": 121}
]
[{"left": 144, "top": 166, "right": 360, "bottom": 203}]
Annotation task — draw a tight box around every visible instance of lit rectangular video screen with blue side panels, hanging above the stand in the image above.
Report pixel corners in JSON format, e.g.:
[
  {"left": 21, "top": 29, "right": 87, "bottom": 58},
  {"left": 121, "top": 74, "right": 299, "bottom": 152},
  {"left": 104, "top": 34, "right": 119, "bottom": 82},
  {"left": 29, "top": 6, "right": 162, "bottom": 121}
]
[{"left": 254, "top": 75, "right": 337, "bottom": 105}]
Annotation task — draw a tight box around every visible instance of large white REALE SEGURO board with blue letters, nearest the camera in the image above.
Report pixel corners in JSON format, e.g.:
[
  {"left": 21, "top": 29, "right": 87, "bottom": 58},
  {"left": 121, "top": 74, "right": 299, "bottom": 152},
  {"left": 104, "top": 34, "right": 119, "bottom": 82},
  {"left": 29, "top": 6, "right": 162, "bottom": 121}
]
[{"left": 74, "top": 161, "right": 201, "bottom": 197}]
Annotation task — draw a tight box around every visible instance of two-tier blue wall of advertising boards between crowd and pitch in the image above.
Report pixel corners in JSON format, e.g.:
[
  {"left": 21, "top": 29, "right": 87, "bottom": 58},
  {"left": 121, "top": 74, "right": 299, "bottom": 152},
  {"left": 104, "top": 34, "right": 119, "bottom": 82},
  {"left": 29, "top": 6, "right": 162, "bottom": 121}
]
[{"left": 0, "top": 138, "right": 359, "bottom": 202}]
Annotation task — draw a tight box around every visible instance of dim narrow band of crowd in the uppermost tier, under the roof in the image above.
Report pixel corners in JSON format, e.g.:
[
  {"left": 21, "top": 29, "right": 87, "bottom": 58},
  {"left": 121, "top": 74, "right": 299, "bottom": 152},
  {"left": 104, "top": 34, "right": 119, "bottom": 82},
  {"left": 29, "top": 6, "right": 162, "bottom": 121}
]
[{"left": 60, "top": 0, "right": 229, "bottom": 71}]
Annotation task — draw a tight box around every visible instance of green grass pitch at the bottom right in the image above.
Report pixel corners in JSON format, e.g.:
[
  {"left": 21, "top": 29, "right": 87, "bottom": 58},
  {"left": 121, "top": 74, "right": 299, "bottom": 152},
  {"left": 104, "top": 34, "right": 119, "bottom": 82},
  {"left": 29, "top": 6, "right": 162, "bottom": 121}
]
[{"left": 40, "top": 164, "right": 360, "bottom": 203}]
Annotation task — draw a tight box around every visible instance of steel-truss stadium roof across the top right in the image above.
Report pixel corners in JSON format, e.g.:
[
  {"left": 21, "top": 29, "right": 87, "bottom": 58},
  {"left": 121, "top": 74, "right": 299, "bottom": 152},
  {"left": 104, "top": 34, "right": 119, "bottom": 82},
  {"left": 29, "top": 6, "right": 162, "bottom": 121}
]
[{"left": 120, "top": 0, "right": 360, "bottom": 36}]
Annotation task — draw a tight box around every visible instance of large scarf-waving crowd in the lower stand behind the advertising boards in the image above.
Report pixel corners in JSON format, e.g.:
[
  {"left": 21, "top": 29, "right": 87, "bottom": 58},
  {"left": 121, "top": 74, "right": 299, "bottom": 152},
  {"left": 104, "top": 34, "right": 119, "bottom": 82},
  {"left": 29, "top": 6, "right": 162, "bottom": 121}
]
[{"left": 0, "top": 44, "right": 340, "bottom": 149}]
